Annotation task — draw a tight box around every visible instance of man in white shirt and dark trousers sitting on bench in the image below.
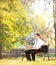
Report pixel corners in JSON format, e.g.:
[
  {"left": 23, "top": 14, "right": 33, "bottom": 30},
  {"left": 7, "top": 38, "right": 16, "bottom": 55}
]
[{"left": 25, "top": 33, "right": 45, "bottom": 61}]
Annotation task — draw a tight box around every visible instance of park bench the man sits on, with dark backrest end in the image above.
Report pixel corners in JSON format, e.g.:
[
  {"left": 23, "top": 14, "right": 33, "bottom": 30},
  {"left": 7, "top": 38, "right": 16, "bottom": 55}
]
[{"left": 22, "top": 44, "right": 49, "bottom": 61}]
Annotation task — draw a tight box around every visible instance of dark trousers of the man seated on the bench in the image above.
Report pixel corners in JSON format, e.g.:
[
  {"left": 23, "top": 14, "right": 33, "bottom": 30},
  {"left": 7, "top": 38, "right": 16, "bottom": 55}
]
[{"left": 25, "top": 49, "right": 41, "bottom": 61}]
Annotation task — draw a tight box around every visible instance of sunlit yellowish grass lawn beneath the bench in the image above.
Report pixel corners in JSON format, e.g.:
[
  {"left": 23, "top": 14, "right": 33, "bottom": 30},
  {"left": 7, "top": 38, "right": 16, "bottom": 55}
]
[{"left": 0, "top": 59, "right": 56, "bottom": 65}]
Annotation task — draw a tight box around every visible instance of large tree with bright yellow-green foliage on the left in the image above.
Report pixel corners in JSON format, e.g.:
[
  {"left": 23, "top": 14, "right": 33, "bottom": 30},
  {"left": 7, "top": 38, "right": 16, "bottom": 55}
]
[{"left": 0, "top": 0, "right": 31, "bottom": 57}]
